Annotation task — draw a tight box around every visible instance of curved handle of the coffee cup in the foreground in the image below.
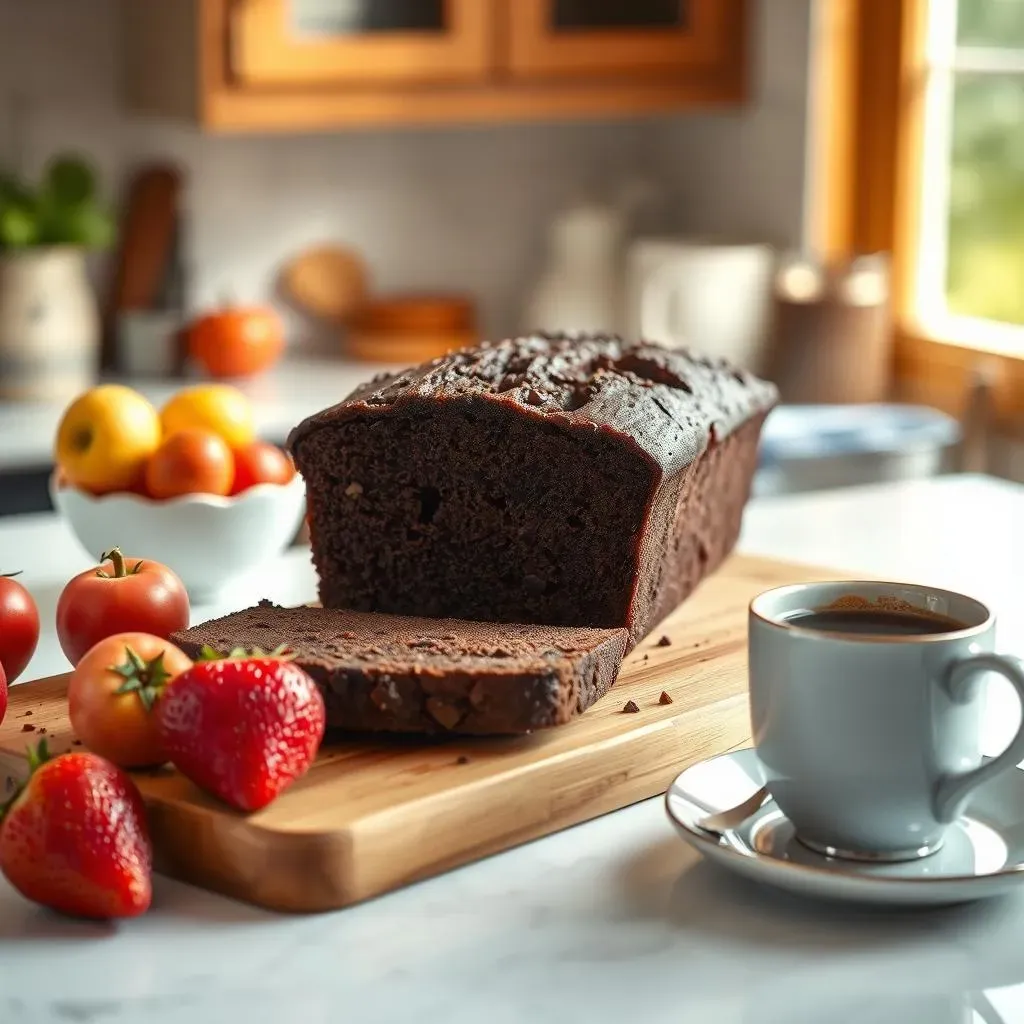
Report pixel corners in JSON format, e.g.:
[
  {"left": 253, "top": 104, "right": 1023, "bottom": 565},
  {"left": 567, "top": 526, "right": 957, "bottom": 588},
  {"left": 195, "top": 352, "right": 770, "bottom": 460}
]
[{"left": 933, "top": 653, "right": 1024, "bottom": 823}]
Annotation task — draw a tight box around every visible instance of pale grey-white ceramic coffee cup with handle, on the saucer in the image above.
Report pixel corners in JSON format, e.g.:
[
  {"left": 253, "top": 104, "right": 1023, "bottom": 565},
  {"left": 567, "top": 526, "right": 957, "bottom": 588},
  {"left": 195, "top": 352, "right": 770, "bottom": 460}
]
[{"left": 749, "top": 582, "right": 1024, "bottom": 860}]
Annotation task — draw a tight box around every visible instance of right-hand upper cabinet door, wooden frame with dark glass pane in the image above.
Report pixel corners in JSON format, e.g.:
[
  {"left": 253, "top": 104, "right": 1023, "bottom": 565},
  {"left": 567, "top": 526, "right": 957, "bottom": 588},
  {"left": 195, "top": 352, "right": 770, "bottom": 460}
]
[{"left": 505, "top": 0, "right": 744, "bottom": 78}]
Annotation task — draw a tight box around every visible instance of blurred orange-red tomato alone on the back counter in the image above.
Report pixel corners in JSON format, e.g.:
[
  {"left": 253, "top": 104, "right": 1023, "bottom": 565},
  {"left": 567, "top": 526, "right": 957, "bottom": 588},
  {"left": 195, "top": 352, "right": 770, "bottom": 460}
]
[{"left": 187, "top": 306, "right": 285, "bottom": 385}]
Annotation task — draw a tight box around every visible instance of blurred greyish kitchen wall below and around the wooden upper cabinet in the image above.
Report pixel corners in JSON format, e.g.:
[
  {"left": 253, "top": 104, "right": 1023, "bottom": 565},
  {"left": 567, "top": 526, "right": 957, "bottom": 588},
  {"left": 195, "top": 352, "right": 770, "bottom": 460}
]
[{"left": 0, "top": 0, "right": 813, "bottom": 344}]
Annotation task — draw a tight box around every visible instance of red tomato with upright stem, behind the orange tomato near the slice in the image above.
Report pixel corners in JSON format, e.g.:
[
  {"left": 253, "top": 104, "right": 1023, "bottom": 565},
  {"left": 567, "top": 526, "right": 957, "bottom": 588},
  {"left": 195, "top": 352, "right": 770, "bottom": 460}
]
[{"left": 57, "top": 548, "right": 188, "bottom": 665}]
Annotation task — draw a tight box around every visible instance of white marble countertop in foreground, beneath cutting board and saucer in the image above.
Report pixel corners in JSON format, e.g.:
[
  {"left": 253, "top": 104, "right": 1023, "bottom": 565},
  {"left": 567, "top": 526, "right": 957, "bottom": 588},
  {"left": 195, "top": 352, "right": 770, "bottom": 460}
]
[{"left": 0, "top": 476, "right": 1024, "bottom": 1024}]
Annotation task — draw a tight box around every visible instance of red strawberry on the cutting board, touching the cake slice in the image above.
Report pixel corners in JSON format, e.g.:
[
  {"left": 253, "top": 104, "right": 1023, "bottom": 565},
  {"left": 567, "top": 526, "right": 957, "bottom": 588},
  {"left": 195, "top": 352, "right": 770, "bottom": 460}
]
[{"left": 153, "top": 650, "right": 327, "bottom": 811}]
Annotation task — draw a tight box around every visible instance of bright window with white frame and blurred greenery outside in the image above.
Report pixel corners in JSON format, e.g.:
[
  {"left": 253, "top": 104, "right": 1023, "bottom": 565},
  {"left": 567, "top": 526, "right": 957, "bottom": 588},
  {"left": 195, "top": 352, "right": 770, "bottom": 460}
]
[{"left": 913, "top": 0, "right": 1024, "bottom": 331}]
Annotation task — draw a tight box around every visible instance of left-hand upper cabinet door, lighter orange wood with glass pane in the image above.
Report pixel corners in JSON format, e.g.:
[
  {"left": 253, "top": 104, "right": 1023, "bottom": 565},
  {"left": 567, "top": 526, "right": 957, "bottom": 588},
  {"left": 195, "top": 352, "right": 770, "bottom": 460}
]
[{"left": 230, "top": 0, "right": 494, "bottom": 85}]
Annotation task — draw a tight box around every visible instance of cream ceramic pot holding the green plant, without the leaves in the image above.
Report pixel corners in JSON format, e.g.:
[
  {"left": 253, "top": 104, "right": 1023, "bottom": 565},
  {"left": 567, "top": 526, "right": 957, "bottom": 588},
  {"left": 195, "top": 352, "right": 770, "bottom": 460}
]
[{"left": 0, "top": 247, "right": 99, "bottom": 400}]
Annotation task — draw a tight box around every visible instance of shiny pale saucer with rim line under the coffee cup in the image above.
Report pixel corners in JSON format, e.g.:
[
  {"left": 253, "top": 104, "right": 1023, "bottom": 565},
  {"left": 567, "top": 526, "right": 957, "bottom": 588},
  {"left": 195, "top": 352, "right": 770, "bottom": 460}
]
[{"left": 665, "top": 750, "right": 1024, "bottom": 906}]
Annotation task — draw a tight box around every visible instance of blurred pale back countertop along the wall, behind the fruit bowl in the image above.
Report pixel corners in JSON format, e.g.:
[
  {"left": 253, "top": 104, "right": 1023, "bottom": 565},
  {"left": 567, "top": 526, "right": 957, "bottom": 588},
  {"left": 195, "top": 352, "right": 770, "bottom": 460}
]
[{"left": 0, "top": 356, "right": 396, "bottom": 472}]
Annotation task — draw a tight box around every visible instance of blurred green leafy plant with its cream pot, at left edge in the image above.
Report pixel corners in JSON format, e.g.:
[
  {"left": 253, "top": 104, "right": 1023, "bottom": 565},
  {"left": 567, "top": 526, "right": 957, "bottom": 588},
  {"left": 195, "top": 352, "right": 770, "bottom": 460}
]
[{"left": 0, "top": 155, "right": 114, "bottom": 399}]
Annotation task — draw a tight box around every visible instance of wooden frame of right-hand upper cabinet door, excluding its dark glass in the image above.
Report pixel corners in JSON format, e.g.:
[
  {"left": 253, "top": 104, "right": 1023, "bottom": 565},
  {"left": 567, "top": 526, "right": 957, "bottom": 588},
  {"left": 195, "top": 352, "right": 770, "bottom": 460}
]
[{"left": 505, "top": 0, "right": 743, "bottom": 78}]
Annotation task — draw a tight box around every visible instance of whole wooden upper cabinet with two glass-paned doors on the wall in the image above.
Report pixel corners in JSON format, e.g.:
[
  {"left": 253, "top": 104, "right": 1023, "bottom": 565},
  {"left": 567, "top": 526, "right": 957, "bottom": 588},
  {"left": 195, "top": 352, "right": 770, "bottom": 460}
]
[{"left": 121, "top": 0, "right": 749, "bottom": 132}]
